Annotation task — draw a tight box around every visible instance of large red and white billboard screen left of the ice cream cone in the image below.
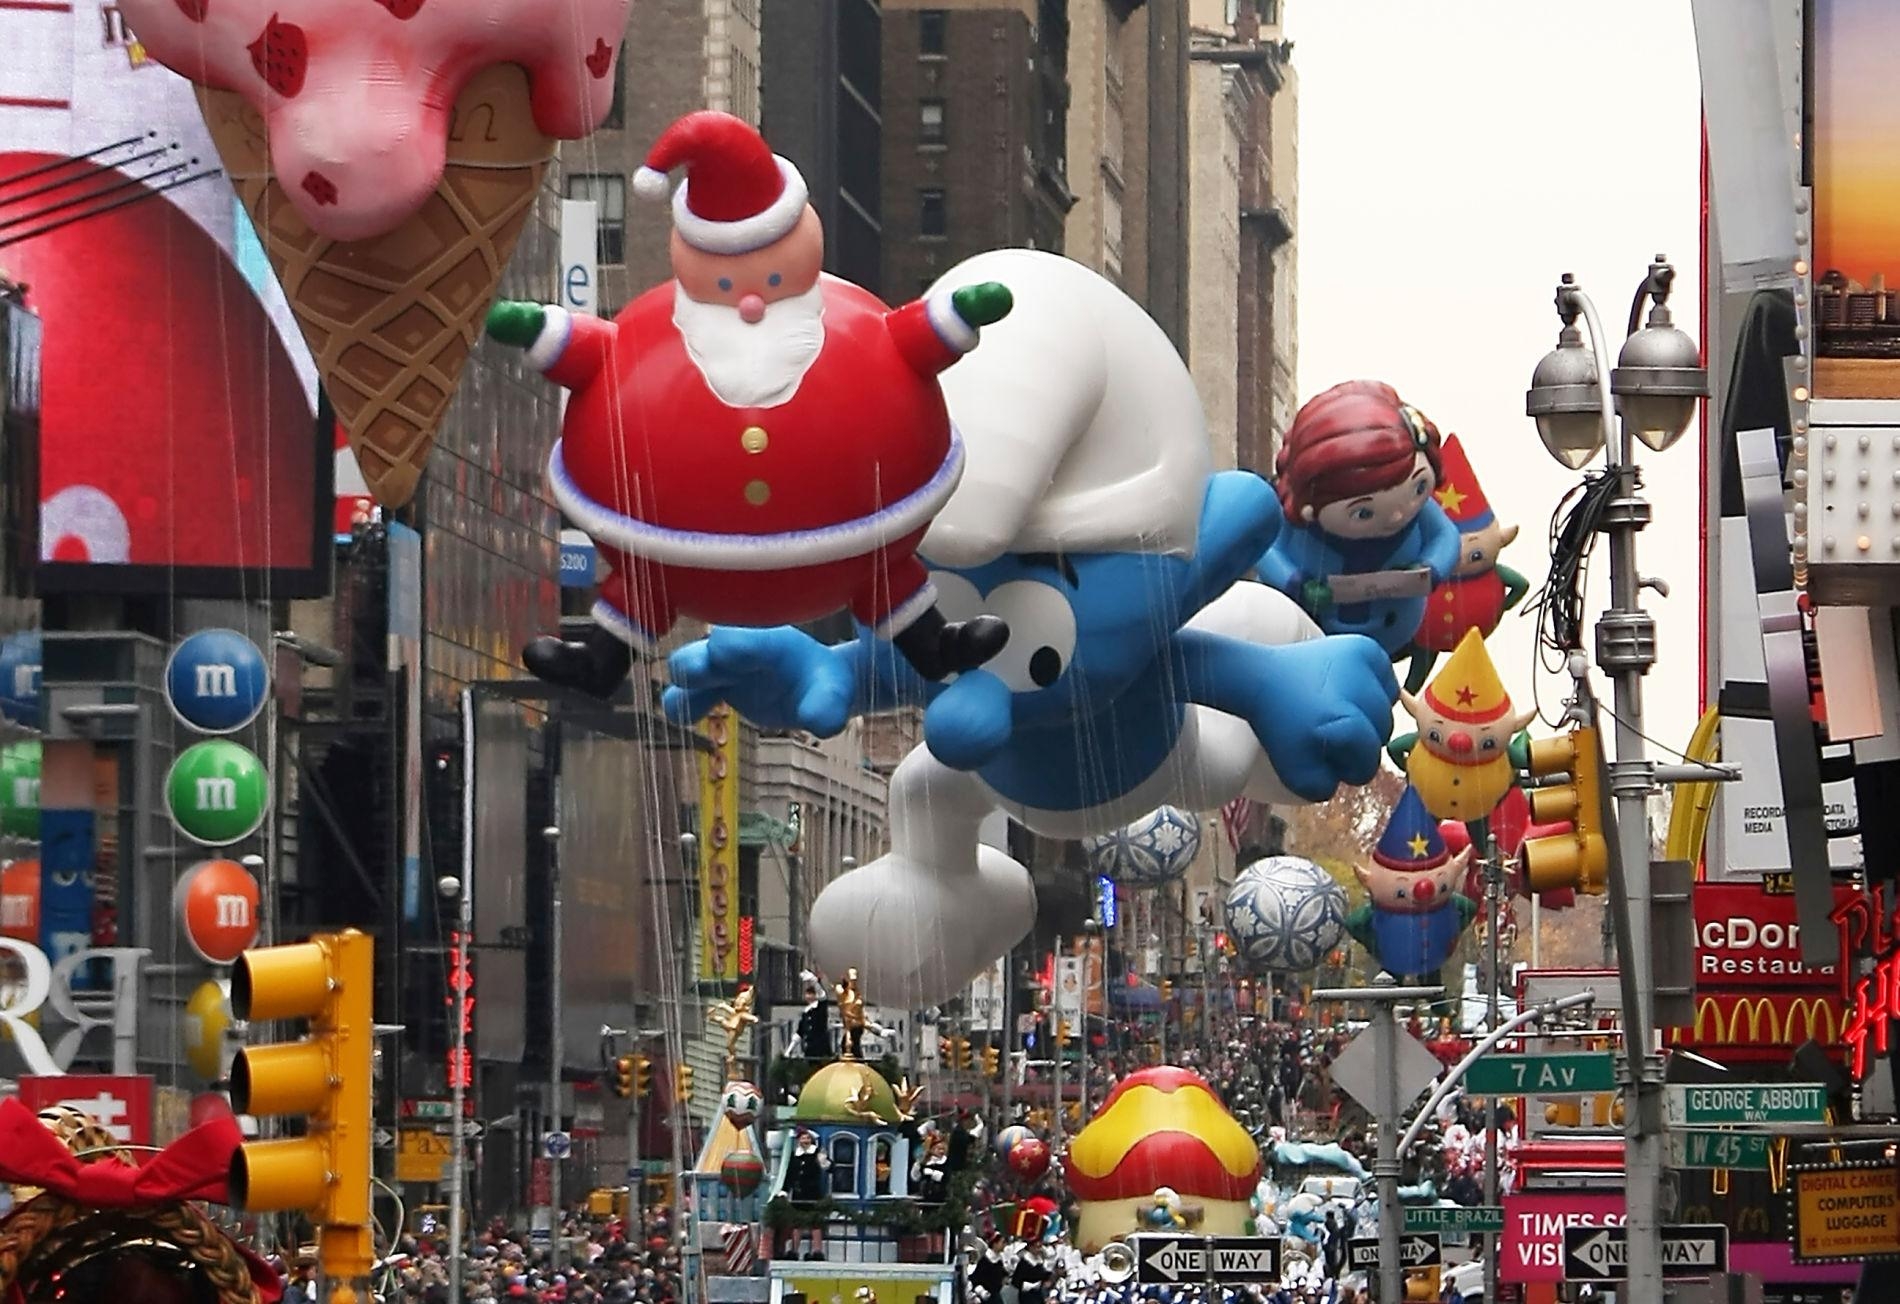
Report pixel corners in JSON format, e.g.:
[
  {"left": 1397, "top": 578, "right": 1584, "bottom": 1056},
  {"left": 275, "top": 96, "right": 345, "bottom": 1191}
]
[{"left": 0, "top": 0, "right": 330, "bottom": 597}]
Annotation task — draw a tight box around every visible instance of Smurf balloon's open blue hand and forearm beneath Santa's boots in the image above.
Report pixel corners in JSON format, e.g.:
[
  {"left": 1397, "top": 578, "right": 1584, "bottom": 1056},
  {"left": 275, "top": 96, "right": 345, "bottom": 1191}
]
[{"left": 661, "top": 625, "right": 859, "bottom": 738}]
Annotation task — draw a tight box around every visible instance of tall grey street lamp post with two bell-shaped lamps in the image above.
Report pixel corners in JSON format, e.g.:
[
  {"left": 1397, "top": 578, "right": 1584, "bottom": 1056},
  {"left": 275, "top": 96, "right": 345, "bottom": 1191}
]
[{"left": 1526, "top": 255, "right": 1708, "bottom": 1300}]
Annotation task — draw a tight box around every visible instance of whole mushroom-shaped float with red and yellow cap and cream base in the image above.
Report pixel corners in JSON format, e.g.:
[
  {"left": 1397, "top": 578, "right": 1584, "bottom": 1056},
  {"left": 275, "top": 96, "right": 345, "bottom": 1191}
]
[{"left": 1064, "top": 1066, "right": 1260, "bottom": 1255}]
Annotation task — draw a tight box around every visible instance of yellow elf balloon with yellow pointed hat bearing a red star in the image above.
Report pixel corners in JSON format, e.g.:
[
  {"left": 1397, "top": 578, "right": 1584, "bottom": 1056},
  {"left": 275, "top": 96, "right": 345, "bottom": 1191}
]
[{"left": 1398, "top": 629, "right": 1537, "bottom": 823}]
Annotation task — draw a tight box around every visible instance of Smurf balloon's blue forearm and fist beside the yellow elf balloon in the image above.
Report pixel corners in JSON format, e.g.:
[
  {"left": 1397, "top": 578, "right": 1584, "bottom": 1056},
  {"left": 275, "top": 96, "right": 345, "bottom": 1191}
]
[{"left": 1174, "top": 629, "right": 1398, "bottom": 802}]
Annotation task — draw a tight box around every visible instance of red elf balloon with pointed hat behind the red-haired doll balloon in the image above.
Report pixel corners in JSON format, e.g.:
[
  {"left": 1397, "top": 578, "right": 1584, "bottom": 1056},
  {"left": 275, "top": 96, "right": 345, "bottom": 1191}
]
[{"left": 1406, "top": 435, "right": 1530, "bottom": 692}]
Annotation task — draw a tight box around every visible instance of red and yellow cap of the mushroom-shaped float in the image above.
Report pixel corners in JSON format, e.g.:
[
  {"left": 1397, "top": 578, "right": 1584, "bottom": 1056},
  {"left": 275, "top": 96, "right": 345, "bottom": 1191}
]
[{"left": 1066, "top": 1066, "right": 1260, "bottom": 1201}]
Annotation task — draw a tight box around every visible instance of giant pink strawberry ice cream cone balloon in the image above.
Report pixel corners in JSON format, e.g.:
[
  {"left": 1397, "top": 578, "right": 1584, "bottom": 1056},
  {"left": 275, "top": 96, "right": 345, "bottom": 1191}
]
[{"left": 120, "top": 0, "right": 631, "bottom": 506}]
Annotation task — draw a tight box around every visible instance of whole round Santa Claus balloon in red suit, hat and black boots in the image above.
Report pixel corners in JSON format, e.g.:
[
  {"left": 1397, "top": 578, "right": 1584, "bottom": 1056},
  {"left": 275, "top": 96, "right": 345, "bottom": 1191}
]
[{"left": 488, "top": 112, "right": 1011, "bottom": 698}]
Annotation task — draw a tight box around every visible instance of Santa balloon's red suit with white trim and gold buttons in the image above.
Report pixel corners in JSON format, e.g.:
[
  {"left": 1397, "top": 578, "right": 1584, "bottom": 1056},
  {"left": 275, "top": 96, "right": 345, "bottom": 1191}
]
[{"left": 528, "top": 285, "right": 977, "bottom": 650}]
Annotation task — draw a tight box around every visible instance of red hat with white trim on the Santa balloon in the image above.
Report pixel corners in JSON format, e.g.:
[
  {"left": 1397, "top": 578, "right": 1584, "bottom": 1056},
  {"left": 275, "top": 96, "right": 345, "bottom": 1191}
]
[{"left": 633, "top": 108, "right": 808, "bottom": 253}]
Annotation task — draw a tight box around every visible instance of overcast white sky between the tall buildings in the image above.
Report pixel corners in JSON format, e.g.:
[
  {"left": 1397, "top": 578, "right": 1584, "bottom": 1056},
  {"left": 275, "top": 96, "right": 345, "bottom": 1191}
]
[{"left": 1284, "top": 0, "right": 1701, "bottom": 747}]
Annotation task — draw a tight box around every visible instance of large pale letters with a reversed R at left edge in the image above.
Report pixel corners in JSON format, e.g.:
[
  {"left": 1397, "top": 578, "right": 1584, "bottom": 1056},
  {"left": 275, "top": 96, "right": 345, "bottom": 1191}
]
[{"left": 0, "top": 937, "right": 152, "bottom": 1078}]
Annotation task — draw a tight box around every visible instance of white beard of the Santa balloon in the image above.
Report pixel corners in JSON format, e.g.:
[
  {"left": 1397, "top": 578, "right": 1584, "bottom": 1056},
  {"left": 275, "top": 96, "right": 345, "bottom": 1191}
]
[{"left": 673, "top": 285, "right": 825, "bottom": 407}]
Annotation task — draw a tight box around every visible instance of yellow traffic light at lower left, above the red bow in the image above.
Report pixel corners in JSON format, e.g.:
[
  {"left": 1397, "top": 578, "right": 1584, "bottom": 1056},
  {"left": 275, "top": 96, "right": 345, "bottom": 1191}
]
[{"left": 230, "top": 928, "right": 376, "bottom": 1300}]
